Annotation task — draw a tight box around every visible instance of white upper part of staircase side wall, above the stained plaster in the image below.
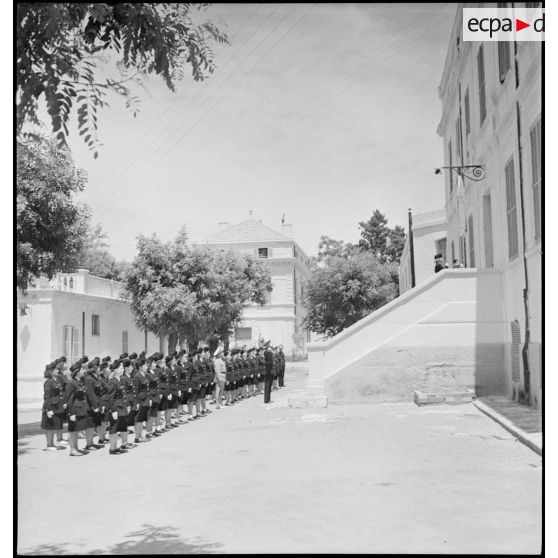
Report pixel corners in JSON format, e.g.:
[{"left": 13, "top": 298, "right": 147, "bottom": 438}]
[{"left": 307, "top": 269, "right": 504, "bottom": 400}]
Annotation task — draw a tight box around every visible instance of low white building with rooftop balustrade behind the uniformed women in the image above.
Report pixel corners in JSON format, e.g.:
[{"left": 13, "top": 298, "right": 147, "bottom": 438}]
[{"left": 17, "top": 269, "right": 160, "bottom": 412}]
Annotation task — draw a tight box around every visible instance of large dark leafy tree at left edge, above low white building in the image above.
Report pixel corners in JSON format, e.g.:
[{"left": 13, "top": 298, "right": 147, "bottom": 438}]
[{"left": 16, "top": 136, "right": 89, "bottom": 292}]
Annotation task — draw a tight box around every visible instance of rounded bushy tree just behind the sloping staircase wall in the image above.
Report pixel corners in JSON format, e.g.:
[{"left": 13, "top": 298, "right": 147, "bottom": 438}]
[{"left": 304, "top": 252, "right": 398, "bottom": 337}]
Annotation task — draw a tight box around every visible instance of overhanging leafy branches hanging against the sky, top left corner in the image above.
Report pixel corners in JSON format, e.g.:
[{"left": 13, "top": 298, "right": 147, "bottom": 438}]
[{"left": 16, "top": 2, "right": 228, "bottom": 157}]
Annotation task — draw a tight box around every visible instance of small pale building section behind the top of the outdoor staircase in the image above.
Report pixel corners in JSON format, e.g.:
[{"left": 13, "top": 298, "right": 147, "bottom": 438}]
[{"left": 399, "top": 209, "right": 451, "bottom": 294}]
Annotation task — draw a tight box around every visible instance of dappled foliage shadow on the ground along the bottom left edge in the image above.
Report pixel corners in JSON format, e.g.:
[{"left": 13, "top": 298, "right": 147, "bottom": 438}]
[{"left": 19, "top": 525, "right": 222, "bottom": 556}]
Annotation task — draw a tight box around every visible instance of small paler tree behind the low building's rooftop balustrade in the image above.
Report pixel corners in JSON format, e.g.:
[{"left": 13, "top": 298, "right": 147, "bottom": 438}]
[{"left": 79, "top": 223, "right": 130, "bottom": 281}]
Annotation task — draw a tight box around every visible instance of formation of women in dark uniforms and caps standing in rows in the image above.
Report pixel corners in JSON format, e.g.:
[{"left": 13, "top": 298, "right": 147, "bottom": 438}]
[{"left": 42, "top": 347, "right": 276, "bottom": 456}]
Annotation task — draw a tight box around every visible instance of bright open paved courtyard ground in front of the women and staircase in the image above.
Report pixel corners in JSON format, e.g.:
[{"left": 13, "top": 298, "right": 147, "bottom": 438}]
[{"left": 18, "top": 369, "right": 542, "bottom": 554}]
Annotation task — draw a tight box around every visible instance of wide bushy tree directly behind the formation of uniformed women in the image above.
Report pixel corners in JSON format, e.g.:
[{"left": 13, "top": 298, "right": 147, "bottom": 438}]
[{"left": 125, "top": 230, "right": 271, "bottom": 347}]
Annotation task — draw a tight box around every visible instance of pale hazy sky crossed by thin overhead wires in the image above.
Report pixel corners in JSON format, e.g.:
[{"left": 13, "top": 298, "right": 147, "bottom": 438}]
[{"left": 60, "top": 3, "right": 457, "bottom": 261}]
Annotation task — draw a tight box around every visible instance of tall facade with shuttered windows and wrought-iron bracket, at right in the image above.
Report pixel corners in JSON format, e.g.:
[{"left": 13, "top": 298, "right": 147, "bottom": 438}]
[{"left": 438, "top": 4, "right": 543, "bottom": 407}]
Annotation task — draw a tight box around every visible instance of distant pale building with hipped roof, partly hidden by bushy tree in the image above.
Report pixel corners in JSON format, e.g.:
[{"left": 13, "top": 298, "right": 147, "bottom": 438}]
[{"left": 199, "top": 219, "right": 310, "bottom": 358}]
